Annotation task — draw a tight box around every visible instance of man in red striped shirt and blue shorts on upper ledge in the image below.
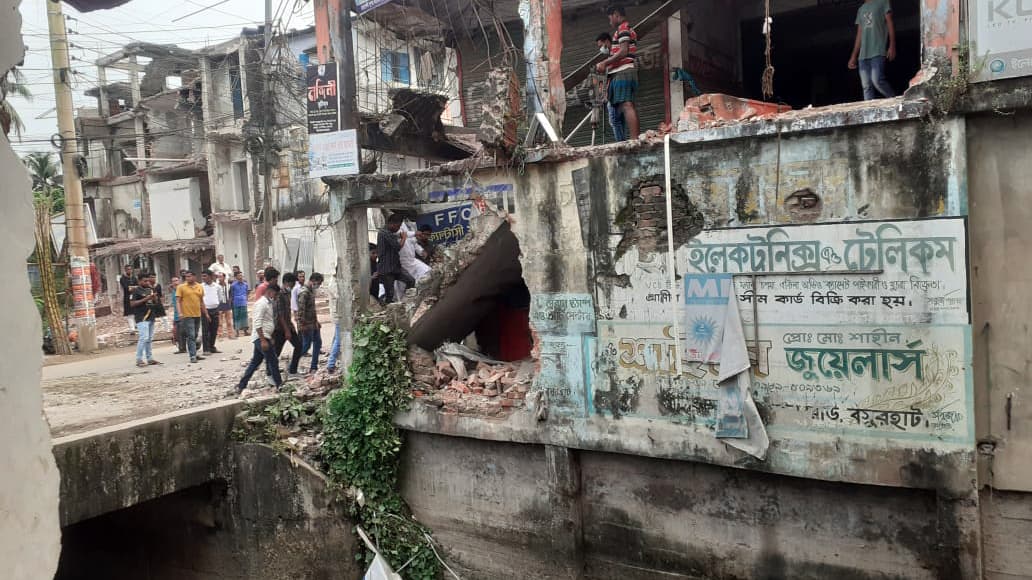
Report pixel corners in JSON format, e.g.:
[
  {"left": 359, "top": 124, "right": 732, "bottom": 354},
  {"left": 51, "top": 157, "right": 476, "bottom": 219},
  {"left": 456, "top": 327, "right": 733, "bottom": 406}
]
[{"left": 596, "top": 6, "right": 639, "bottom": 139}]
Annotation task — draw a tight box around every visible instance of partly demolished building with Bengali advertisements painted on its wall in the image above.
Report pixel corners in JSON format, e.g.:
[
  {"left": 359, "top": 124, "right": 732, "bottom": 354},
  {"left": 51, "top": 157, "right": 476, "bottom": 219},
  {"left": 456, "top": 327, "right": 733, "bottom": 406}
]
[{"left": 325, "top": 1, "right": 1032, "bottom": 578}]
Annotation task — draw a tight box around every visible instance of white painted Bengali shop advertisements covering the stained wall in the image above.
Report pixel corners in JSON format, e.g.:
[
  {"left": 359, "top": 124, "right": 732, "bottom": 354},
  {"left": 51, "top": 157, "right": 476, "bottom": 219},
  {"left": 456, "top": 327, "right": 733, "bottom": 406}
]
[{"left": 591, "top": 219, "right": 973, "bottom": 444}]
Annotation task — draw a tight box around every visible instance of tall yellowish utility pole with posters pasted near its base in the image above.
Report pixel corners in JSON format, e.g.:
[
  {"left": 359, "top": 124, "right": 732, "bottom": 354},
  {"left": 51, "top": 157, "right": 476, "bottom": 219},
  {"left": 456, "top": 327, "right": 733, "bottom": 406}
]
[{"left": 46, "top": 0, "right": 97, "bottom": 352}]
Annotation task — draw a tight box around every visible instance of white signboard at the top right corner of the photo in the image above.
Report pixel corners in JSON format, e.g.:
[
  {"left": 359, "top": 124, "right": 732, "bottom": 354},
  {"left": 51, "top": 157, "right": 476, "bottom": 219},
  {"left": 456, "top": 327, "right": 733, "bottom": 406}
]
[{"left": 967, "top": 0, "right": 1032, "bottom": 80}]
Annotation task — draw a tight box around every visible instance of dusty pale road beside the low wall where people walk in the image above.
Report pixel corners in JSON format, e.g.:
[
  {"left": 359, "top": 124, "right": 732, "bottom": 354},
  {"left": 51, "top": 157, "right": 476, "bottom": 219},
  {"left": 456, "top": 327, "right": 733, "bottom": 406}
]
[{"left": 42, "top": 323, "right": 333, "bottom": 437}]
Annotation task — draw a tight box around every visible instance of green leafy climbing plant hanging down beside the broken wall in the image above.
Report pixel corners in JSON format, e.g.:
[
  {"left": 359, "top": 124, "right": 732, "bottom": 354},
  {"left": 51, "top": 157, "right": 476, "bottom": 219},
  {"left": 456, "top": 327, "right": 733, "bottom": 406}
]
[{"left": 321, "top": 319, "right": 441, "bottom": 579}]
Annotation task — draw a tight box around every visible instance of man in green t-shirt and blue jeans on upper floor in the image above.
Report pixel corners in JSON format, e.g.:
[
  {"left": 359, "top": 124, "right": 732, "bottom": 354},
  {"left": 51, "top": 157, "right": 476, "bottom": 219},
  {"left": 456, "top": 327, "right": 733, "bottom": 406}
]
[{"left": 849, "top": 0, "right": 896, "bottom": 101}]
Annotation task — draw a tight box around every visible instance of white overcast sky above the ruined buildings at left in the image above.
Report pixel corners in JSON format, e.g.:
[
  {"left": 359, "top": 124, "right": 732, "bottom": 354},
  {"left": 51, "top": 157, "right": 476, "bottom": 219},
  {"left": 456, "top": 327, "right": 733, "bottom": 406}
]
[{"left": 10, "top": 0, "right": 314, "bottom": 154}]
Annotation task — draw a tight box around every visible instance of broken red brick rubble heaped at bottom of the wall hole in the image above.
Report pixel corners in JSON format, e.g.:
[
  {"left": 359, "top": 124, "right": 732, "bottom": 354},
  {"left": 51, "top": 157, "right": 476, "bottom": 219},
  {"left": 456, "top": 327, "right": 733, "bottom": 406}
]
[{"left": 409, "top": 347, "right": 535, "bottom": 417}]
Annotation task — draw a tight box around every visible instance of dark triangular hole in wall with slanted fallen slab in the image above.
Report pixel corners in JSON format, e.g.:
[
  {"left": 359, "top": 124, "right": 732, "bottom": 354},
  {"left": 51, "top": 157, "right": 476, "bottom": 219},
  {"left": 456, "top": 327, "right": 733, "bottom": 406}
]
[{"left": 409, "top": 222, "right": 534, "bottom": 361}]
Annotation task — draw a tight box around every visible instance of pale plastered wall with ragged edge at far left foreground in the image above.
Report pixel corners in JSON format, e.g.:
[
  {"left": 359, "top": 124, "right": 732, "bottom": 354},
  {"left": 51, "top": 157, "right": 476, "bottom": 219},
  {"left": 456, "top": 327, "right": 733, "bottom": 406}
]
[{"left": 0, "top": 0, "right": 61, "bottom": 578}]
